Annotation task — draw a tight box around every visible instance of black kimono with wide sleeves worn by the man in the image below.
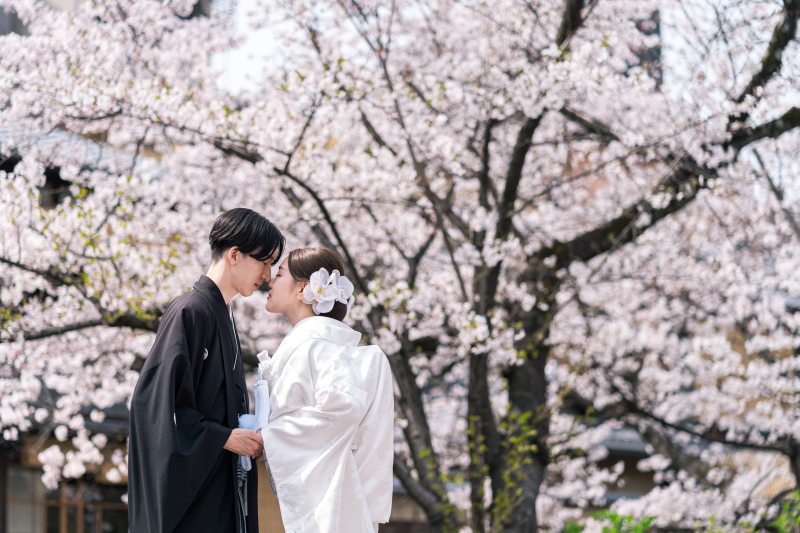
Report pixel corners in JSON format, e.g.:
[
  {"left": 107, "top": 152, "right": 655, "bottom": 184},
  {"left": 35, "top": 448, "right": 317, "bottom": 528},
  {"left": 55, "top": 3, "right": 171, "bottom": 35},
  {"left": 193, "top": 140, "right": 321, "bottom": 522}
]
[{"left": 128, "top": 276, "right": 258, "bottom": 533}]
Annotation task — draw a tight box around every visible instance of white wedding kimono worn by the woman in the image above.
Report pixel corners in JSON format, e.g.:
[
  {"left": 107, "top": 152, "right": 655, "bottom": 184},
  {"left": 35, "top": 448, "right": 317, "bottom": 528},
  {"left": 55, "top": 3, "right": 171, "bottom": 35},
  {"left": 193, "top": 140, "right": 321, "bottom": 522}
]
[{"left": 256, "top": 316, "right": 394, "bottom": 533}]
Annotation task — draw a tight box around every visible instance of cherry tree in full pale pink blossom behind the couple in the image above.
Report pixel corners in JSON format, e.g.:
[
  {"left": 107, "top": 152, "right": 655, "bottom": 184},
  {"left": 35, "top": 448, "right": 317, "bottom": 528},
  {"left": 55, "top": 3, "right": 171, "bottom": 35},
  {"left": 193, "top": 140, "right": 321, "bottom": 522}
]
[{"left": 0, "top": 0, "right": 800, "bottom": 532}]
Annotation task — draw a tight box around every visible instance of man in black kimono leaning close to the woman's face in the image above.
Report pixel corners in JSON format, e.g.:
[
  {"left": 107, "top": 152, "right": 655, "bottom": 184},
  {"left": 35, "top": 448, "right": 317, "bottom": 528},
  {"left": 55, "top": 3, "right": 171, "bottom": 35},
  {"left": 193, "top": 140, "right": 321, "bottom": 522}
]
[{"left": 128, "top": 208, "right": 285, "bottom": 533}]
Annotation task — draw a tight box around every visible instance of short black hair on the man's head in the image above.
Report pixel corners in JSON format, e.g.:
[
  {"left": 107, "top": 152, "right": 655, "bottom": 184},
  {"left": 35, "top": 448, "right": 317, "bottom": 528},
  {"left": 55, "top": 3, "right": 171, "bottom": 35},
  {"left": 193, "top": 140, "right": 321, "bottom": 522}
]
[{"left": 208, "top": 207, "right": 286, "bottom": 265}]
